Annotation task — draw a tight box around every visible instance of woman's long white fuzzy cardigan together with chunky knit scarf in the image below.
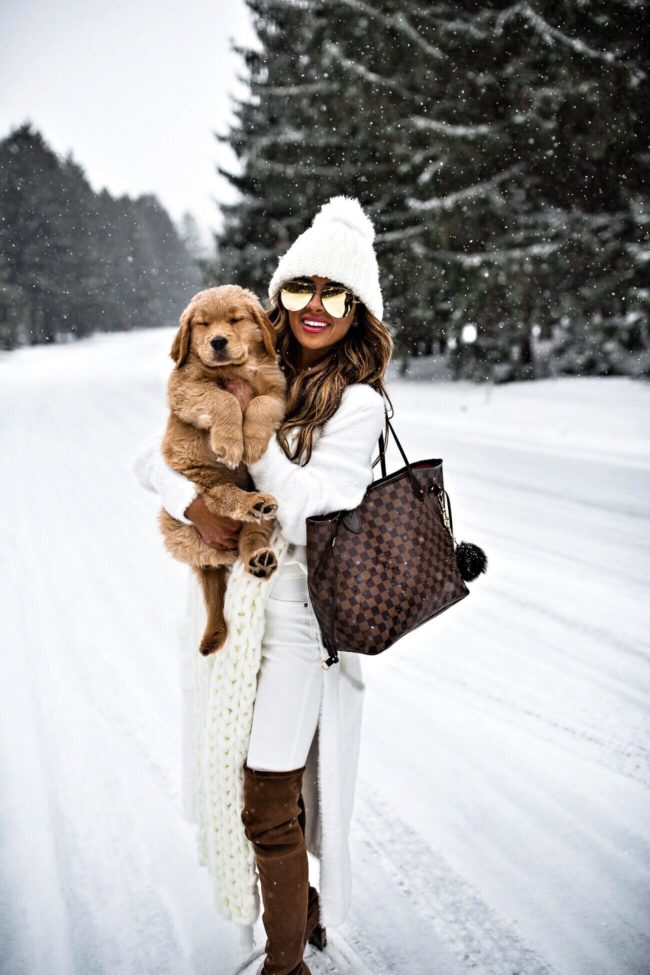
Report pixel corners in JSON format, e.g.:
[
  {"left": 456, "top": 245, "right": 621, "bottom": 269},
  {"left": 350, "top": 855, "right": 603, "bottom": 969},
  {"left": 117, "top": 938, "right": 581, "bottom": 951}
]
[{"left": 134, "top": 383, "right": 385, "bottom": 945}]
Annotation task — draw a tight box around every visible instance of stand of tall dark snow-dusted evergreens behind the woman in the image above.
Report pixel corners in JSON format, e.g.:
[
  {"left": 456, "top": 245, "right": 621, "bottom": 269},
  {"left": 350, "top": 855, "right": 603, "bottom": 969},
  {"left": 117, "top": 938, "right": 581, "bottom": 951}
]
[{"left": 218, "top": 0, "right": 650, "bottom": 378}]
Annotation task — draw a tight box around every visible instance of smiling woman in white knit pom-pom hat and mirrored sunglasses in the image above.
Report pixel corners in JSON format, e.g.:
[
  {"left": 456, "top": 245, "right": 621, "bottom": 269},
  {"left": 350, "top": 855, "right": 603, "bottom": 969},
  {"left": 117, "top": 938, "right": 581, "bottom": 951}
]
[{"left": 136, "top": 197, "right": 393, "bottom": 975}]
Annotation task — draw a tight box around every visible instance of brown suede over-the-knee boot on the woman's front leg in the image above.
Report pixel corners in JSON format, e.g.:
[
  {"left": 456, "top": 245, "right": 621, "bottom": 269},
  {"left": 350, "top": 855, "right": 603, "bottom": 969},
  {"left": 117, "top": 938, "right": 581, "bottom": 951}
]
[{"left": 241, "top": 763, "right": 311, "bottom": 975}]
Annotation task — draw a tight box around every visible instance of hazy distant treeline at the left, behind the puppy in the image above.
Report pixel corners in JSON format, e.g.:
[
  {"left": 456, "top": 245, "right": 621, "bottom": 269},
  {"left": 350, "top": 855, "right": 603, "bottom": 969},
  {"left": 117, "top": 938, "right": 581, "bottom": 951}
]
[{"left": 0, "top": 123, "right": 200, "bottom": 348}]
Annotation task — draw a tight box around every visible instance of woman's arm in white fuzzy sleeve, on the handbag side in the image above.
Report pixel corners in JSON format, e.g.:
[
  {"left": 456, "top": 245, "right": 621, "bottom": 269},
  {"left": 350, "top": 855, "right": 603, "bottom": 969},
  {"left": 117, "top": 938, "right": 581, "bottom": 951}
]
[{"left": 248, "top": 383, "right": 385, "bottom": 545}]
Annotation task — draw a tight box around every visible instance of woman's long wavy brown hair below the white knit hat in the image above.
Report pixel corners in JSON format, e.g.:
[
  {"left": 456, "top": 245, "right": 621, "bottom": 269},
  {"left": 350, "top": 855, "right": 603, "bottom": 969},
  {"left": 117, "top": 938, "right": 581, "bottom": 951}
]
[{"left": 267, "top": 298, "right": 394, "bottom": 467}]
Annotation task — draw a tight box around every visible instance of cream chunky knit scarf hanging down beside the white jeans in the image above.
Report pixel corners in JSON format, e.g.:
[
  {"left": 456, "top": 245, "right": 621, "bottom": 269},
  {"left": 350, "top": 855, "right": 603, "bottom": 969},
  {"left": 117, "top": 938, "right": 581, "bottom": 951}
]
[{"left": 187, "top": 522, "right": 289, "bottom": 943}]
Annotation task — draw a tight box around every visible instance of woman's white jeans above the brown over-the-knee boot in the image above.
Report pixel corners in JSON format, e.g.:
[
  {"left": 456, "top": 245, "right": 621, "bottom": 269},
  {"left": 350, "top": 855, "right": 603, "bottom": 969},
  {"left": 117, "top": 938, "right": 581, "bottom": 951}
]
[{"left": 246, "top": 563, "right": 324, "bottom": 772}]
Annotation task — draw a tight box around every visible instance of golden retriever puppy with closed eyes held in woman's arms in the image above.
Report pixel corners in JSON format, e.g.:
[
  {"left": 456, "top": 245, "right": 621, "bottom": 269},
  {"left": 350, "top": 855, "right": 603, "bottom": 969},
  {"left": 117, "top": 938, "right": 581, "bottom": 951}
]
[{"left": 160, "top": 285, "right": 286, "bottom": 654}]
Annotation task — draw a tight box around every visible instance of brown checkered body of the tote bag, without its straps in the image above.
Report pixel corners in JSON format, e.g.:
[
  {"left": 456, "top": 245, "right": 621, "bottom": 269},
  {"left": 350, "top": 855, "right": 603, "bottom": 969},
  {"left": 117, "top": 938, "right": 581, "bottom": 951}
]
[{"left": 306, "top": 460, "right": 469, "bottom": 654}]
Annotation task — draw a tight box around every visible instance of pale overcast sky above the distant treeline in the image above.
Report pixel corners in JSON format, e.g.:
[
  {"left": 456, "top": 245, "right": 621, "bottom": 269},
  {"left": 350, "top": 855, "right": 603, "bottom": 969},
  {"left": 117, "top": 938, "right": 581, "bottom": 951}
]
[{"left": 0, "top": 0, "right": 255, "bottom": 246}]
